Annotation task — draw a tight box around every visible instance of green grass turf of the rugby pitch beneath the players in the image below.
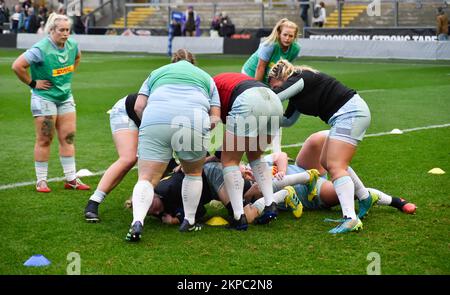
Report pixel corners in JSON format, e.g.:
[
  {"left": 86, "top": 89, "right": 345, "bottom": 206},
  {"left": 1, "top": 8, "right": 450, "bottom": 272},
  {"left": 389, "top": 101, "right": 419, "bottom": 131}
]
[{"left": 0, "top": 50, "right": 450, "bottom": 274}]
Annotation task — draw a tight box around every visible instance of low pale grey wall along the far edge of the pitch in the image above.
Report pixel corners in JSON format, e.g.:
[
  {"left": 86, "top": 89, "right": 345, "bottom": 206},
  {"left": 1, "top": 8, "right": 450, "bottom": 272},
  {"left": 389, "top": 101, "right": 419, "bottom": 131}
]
[{"left": 12, "top": 34, "right": 450, "bottom": 60}]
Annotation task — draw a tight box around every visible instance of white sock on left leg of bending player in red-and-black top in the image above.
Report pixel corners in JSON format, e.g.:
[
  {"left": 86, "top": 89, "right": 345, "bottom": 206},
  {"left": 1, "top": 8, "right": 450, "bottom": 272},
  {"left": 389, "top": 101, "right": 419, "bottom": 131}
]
[{"left": 223, "top": 166, "right": 244, "bottom": 220}]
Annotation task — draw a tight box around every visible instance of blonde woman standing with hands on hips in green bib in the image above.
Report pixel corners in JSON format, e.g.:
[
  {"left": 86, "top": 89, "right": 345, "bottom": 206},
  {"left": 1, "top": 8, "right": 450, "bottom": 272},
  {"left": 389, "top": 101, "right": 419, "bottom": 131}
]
[{"left": 12, "top": 13, "right": 90, "bottom": 193}]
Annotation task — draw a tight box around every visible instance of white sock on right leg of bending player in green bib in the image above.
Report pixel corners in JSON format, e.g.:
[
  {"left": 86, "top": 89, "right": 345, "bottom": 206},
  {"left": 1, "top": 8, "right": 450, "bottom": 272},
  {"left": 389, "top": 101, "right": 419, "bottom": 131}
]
[{"left": 181, "top": 175, "right": 203, "bottom": 224}]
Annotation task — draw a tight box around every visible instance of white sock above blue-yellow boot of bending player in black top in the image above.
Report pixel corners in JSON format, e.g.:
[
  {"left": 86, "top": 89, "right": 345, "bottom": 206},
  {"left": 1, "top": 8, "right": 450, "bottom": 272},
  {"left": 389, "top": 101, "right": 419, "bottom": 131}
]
[{"left": 333, "top": 176, "right": 356, "bottom": 219}]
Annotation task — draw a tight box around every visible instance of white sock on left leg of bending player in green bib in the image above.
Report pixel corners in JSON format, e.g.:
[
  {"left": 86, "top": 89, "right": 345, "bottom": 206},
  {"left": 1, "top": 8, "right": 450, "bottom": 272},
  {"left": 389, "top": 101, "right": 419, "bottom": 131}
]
[{"left": 131, "top": 180, "right": 154, "bottom": 225}]
